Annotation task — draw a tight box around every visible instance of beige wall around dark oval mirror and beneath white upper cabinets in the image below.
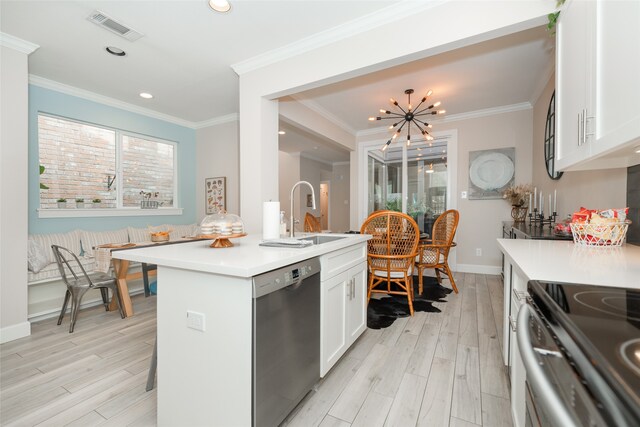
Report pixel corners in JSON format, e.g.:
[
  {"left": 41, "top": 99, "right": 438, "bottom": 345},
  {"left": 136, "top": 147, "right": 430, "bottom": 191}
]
[{"left": 533, "top": 76, "right": 627, "bottom": 220}]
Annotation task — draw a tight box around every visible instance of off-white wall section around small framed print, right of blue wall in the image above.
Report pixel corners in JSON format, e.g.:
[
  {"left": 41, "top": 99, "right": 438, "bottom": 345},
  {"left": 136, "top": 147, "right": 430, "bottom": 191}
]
[{"left": 194, "top": 120, "right": 240, "bottom": 223}]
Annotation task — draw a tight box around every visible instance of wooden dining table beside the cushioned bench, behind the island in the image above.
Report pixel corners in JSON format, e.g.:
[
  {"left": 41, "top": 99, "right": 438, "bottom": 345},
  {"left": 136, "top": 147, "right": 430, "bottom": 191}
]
[{"left": 94, "top": 237, "right": 205, "bottom": 317}]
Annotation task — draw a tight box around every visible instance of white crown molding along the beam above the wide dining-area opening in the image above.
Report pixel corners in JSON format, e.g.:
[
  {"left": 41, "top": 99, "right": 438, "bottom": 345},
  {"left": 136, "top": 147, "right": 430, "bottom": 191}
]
[{"left": 231, "top": 0, "right": 446, "bottom": 76}]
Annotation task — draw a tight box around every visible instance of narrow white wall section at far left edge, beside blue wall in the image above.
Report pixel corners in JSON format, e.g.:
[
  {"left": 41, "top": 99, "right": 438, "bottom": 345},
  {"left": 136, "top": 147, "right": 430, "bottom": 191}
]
[{"left": 0, "top": 41, "right": 35, "bottom": 342}]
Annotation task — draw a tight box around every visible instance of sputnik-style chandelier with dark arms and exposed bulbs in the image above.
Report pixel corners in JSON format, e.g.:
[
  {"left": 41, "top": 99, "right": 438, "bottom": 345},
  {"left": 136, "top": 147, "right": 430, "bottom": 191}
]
[{"left": 369, "top": 89, "right": 445, "bottom": 151}]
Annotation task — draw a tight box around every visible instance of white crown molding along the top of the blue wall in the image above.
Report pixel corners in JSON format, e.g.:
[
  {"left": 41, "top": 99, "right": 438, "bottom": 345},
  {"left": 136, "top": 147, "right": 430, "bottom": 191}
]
[{"left": 29, "top": 74, "right": 196, "bottom": 129}]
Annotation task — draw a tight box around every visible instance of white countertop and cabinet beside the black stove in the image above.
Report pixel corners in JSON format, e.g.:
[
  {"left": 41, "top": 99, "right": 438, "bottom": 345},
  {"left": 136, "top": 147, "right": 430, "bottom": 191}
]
[{"left": 498, "top": 239, "right": 640, "bottom": 427}]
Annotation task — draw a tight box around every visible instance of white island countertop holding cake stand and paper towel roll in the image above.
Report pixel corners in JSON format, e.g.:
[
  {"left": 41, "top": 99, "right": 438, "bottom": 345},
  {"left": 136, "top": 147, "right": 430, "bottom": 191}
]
[{"left": 111, "top": 233, "right": 371, "bottom": 277}]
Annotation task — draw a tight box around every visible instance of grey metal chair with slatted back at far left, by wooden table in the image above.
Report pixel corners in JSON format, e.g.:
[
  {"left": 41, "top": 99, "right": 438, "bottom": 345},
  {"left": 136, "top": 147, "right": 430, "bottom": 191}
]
[{"left": 51, "top": 245, "right": 124, "bottom": 333}]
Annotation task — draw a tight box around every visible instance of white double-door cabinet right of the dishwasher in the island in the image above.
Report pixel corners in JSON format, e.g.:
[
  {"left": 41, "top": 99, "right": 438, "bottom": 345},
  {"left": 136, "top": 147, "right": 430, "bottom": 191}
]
[{"left": 320, "top": 245, "right": 367, "bottom": 376}]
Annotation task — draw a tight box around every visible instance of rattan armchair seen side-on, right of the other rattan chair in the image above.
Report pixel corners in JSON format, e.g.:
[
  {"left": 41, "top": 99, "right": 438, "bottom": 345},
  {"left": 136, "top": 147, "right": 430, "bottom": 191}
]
[{"left": 416, "top": 209, "right": 460, "bottom": 293}]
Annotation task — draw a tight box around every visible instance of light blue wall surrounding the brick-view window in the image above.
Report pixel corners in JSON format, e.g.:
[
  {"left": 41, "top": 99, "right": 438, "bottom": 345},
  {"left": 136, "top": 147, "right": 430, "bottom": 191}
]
[{"left": 29, "top": 85, "right": 196, "bottom": 234}]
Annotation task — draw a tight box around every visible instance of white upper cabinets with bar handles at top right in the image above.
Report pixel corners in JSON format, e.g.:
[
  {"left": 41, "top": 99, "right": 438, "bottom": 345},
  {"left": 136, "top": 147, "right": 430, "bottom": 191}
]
[{"left": 556, "top": 0, "right": 640, "bottom": 170}]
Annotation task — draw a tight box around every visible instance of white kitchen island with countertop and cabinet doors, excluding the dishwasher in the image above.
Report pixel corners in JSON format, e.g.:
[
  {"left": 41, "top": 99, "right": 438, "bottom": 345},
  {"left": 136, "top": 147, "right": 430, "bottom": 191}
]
[{"left": 113, "top": 234, "right": 370, "bottom": 426}]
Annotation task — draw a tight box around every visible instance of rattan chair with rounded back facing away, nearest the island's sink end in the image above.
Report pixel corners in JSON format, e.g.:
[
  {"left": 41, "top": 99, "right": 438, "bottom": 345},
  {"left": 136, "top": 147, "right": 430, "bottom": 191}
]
[{"left": 360, "top": 211, "right": 420, "bottom": 316}]
